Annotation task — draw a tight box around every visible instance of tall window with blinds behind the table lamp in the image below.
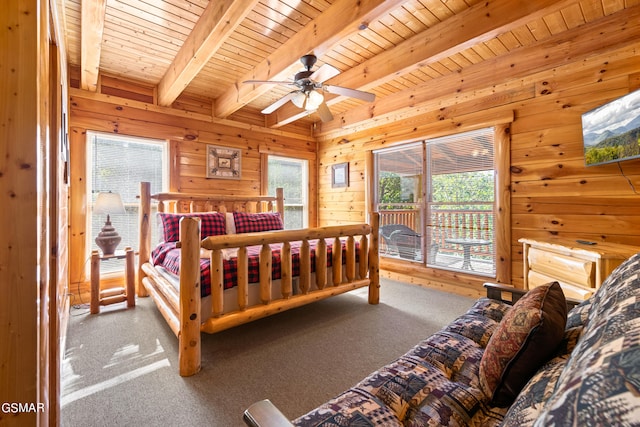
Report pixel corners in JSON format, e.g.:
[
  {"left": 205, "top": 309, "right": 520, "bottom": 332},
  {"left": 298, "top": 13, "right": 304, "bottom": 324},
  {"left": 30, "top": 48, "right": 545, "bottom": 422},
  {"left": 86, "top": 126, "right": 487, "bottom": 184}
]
[{"left": 87, "top": 132, "right": 168, "bottom": 272}]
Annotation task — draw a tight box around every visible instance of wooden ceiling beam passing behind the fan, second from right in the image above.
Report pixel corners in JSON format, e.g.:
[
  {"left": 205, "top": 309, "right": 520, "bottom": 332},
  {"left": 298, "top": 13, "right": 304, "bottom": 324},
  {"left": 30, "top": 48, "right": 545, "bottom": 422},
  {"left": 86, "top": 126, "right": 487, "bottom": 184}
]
[{"left": 267, "top": 0, "right": 575, "bottom": 128}]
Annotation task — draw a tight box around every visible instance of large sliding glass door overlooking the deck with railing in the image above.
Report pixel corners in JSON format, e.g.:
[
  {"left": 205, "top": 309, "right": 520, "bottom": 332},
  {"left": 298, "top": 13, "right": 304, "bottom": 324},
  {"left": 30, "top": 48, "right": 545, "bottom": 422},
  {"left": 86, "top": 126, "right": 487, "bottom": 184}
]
[{"left": 374, "top": 129, "right": 496, "bottom": 276}]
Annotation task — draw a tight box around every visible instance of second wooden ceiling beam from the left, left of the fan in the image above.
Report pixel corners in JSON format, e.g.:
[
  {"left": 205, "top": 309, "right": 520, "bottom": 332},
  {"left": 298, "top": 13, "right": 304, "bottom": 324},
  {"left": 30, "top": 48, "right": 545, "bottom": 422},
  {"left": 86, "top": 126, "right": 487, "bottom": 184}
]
[{"left": 156, "top": 0, "right": 259, "bottom": 106}]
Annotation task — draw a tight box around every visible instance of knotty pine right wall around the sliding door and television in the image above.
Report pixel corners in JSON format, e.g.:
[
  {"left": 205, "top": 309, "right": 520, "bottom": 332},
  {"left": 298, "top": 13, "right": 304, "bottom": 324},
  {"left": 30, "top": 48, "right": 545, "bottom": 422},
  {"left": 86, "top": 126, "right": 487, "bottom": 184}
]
[{"left": 318, "top": 23, "right": 640, "bottom": 296}]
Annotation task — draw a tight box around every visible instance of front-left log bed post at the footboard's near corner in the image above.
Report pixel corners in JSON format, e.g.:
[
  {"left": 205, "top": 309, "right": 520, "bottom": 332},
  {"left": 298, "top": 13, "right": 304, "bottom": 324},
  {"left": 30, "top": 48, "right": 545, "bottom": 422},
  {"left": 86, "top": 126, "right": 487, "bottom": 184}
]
[{"left": 178, "top": 217, "right": 201, "bottom": 377}]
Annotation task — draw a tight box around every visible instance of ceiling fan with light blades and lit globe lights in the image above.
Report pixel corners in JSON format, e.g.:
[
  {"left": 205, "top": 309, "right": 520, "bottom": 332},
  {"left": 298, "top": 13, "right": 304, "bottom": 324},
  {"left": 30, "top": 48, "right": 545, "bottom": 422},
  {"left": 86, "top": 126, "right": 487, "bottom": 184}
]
[{"left": 243, "top": 55, "right": 376, "bottom": 122}]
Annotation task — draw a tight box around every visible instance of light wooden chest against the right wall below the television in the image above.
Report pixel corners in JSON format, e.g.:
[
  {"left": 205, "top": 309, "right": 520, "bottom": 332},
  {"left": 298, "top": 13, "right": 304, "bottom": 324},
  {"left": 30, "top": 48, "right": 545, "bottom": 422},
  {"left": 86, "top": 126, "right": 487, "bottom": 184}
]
[{"left": 518, "top": 238, "right": 640, "bottom": 299}]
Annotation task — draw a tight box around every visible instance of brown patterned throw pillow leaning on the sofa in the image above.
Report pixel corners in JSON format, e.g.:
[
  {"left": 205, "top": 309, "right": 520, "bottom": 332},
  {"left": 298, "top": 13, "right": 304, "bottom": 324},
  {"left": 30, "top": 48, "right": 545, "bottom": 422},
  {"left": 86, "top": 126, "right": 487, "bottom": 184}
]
[{"left": 479, "top": 282, "right": 567, "bottom": 407}]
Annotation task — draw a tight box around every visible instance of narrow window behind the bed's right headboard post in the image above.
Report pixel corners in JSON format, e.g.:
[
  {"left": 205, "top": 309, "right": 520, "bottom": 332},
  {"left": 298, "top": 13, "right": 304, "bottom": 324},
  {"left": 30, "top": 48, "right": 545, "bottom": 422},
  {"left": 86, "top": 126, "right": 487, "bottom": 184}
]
[{"left": 267, "top": 155, "right": 309, "bottom": 229}]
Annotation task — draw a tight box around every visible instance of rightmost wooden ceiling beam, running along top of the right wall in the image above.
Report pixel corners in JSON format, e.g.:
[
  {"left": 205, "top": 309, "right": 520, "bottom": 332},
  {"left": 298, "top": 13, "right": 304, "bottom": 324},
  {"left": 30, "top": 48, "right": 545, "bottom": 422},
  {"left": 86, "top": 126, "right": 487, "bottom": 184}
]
[{"left": 315, "top": 5, "right": 640, "bottom": 137}]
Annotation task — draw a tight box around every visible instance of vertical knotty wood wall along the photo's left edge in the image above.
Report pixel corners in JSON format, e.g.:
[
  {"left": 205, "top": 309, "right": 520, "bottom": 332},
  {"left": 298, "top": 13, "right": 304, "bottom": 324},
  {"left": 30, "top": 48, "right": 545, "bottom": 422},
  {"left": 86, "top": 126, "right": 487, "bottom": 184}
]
[{"left": 0, "top": 0, "right": 67, "bottom": 426}]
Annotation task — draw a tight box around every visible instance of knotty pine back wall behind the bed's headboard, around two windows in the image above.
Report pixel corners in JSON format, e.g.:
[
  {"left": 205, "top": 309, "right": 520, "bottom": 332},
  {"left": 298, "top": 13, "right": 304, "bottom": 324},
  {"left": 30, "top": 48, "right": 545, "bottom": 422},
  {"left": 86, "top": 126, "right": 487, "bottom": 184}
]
[{"left": 70, "top": 80, "right": 317, "bottom": 301}]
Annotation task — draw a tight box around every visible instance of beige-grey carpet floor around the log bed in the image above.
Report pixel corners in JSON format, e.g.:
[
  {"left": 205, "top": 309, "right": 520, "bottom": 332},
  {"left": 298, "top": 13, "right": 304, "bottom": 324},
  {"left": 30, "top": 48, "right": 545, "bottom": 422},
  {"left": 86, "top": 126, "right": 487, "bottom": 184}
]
[{"left": 61, "top": 280, "right": 473, "bottom": 427}]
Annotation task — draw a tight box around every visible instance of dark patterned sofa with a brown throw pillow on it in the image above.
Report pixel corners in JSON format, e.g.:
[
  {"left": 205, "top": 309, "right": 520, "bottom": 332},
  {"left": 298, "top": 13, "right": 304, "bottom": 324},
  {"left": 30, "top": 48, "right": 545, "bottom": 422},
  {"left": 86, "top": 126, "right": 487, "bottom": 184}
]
[{"left": 244, "top": 254, "right": 640, "bottom": 427}]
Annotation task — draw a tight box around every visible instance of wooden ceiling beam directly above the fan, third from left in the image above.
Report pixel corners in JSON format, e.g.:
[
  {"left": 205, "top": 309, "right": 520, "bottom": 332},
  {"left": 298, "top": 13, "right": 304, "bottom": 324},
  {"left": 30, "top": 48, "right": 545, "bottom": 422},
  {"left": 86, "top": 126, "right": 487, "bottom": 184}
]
[{"left": 214, "top": 0, "right": 403, "bottom": 118}]
